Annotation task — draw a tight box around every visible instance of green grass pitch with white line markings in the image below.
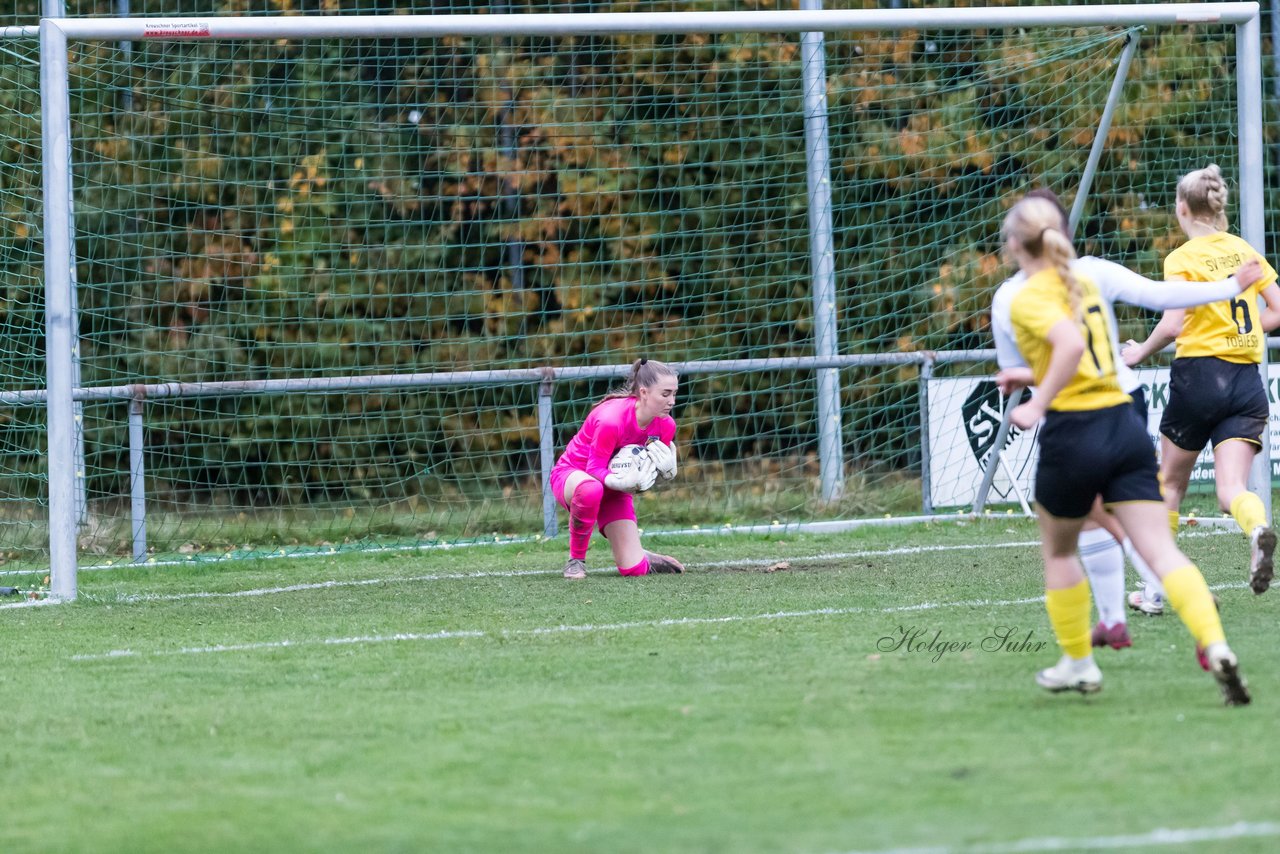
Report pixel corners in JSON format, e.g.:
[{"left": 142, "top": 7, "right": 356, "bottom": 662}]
[{"left": 0, "top": 520, "right": 1280, "bottom": 853}]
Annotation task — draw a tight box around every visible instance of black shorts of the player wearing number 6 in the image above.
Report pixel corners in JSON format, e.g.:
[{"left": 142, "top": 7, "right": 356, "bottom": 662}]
[{"left": 1160, "top": 356, "right": 1271, "bottom": 451}]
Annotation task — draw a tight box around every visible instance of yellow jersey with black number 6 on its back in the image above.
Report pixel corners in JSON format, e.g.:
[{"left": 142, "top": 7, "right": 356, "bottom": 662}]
[{"left": 1165, "top": 232, "right": 1276, "bottom": 365}]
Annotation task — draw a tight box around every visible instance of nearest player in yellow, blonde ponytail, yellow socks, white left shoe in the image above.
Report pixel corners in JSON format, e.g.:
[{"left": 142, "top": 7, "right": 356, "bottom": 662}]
[{"left": 1002, "top": 198, "right": 1249, "bottom": 705}]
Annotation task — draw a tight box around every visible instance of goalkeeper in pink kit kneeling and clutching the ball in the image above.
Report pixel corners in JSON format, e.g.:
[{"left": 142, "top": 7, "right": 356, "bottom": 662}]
[{"left": 550, "top": 359, "right": 685, "bottom": 579}]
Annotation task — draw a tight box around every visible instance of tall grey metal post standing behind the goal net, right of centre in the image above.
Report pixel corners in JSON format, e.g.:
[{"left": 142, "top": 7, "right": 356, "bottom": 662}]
[{"left": 800, "top": 0, "right": 845, "bottom": 502}]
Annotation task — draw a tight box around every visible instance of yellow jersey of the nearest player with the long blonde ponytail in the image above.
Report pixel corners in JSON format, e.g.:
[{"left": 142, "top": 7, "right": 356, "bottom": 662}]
[{"left": 1009, "top": 269, "right": 1130, "bottom": 412}]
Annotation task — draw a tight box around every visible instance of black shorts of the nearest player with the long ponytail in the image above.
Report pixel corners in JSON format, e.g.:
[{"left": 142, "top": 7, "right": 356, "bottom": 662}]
[{"left": 1036, "top": 403, "right": 1161, "bottom": 519}]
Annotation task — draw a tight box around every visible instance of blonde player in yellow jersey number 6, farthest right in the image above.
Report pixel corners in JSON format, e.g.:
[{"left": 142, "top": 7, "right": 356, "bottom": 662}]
[{"left": 1123, "top": 165, "right": 1280, "bottom": 601}]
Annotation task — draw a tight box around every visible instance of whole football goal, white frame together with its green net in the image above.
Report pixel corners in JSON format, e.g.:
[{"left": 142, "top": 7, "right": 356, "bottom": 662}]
[{"left": 37, "top": 3, "right": 1270, "bottom": 599}]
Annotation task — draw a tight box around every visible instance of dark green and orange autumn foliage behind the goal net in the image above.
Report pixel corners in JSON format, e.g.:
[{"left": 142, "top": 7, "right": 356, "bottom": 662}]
[{"left": 0, "top": 0, "right": 1276, "bottom": 545}]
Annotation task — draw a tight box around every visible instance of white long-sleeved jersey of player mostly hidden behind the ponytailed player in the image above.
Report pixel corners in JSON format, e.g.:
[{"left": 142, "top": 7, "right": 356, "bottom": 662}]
[{"left": 991, "top": 255, "right": 1240, "bottom": 393}]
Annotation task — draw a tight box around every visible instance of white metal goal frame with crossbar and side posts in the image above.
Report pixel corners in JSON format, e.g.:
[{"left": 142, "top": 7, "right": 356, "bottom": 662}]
[{"left": 35, "top": 0, "right": 1271, "bottom": 600}]
